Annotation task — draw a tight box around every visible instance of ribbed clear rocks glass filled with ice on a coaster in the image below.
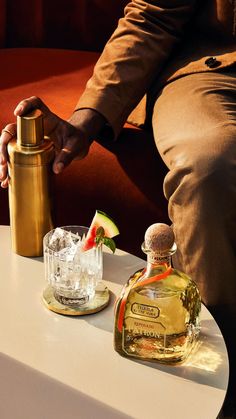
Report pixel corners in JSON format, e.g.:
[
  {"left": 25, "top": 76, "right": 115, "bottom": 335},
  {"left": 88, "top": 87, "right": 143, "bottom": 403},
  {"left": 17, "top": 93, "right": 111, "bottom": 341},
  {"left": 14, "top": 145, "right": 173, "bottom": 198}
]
[{"left": 43, "top": 226, "right": 103, "bottom": 307}]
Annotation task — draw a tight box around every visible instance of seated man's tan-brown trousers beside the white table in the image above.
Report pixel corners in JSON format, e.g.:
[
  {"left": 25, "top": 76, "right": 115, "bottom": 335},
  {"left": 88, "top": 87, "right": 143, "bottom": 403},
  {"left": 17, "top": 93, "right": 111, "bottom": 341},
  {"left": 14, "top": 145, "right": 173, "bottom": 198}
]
[{"left": 152, "top": 70, "right": 236, "bottom": 416}]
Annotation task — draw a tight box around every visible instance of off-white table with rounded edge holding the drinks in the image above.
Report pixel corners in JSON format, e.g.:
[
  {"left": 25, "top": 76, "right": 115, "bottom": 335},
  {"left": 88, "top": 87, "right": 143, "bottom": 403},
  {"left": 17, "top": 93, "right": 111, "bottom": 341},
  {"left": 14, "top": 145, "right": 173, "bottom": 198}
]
[{"left": 0, "top": 226, "right": 229, "bottom": 419}]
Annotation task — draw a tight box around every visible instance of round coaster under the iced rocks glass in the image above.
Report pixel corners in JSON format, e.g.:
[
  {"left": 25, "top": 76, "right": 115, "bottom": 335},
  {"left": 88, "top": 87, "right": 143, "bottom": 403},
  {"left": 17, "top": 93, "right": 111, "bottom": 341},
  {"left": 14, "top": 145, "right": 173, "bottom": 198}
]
[{"left": 43, "top": 284, "right": 110, "bottom": 316}]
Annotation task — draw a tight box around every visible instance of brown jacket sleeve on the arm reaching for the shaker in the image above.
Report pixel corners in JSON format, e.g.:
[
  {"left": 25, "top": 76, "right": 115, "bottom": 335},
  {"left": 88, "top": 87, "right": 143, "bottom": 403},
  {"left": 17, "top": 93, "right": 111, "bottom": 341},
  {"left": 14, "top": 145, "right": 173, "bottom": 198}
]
[{"left": 76, "top": 0, "right": 197, "bottom": 138}]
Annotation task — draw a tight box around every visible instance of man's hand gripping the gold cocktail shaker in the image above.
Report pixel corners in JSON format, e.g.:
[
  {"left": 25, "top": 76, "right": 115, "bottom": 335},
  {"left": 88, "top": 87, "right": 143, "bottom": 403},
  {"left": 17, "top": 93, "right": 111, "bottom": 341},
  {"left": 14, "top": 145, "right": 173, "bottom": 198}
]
[{"left": 0, "top": 96, "right": 106, "bottom": 188}]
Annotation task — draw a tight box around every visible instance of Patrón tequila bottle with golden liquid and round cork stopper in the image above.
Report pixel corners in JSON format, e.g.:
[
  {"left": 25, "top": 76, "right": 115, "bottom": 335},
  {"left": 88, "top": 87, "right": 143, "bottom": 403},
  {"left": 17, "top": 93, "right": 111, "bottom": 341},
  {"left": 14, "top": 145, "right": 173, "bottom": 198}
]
[{"left": 114, "top": 223, "right": 201, "bottom": 363}]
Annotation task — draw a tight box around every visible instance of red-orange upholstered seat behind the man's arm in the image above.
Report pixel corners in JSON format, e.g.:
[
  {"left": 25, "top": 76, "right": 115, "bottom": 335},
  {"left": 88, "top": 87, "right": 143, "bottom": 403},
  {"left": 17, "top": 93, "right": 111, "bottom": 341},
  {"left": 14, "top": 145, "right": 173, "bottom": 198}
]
[{"left": 0, "top": 0, "right": 168, "bottom": 256}]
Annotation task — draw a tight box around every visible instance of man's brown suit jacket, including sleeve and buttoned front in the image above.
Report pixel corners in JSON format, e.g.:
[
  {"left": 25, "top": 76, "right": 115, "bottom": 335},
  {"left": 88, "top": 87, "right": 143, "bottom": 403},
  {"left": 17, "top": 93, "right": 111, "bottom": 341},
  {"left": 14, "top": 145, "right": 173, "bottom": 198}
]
[{"left": 76, "top": 0, "right": 236, "bottom": 137}]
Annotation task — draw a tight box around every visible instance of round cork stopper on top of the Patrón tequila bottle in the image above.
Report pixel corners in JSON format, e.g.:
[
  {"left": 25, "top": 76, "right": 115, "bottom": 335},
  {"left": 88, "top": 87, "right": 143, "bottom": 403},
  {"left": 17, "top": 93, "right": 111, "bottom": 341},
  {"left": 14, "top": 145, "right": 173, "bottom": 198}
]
[{"left": 144, "top": 223, "right": 175, "bottom": 252}]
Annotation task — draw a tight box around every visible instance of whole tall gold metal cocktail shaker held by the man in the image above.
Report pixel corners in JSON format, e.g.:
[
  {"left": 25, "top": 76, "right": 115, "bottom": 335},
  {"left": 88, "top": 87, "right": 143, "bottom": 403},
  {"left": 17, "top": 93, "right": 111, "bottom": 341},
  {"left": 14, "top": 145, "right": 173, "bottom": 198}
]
[{"left": 8, "top": 109, "right": 54, "bottom": 256}]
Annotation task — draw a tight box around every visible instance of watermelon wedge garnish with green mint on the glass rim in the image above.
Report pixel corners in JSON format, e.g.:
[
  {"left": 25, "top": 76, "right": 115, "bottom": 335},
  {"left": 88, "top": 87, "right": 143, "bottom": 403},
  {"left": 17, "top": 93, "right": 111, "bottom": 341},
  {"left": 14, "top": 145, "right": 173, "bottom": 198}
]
[{"left": 83, "top": 210, "right": 119, "bottom": 253}]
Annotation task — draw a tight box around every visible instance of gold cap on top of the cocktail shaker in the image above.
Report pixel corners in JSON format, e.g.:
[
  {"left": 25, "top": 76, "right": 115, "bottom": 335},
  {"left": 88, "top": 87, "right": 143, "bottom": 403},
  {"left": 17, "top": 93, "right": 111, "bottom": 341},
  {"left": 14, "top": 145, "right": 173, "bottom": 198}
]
[{"left": 17, "top": 109, "right": 44, "bottom": 147}]
